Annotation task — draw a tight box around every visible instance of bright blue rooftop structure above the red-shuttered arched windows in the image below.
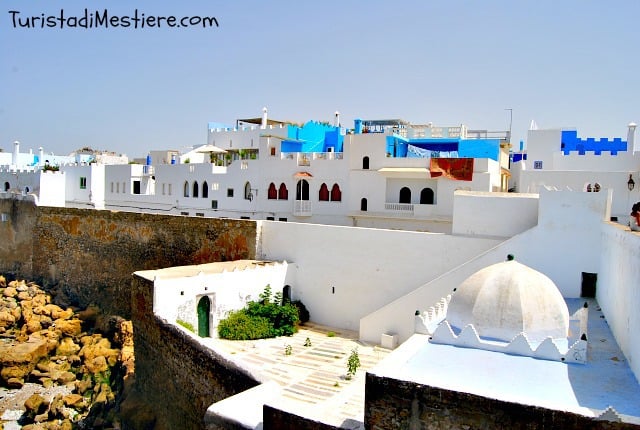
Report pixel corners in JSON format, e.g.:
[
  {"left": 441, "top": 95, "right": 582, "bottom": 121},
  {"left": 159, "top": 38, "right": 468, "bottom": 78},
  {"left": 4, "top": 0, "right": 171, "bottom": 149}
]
[{"left": 280, "top": 121, "right": 344, "bottom": 152}]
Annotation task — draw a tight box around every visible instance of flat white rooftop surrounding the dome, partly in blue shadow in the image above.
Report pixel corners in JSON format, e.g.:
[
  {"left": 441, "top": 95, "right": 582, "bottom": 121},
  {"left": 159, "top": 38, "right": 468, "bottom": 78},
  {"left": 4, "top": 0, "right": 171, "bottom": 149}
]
[{"left": 369, "top": 298, "right": 640, "bottom": 424}]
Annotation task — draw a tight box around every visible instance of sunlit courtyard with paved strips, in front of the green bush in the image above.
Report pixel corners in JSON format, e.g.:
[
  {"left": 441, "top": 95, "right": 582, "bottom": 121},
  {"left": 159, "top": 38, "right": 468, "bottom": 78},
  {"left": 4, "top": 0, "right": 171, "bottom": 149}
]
[{"left": 201, "top": 323, "right": 390, "bottom": 429}]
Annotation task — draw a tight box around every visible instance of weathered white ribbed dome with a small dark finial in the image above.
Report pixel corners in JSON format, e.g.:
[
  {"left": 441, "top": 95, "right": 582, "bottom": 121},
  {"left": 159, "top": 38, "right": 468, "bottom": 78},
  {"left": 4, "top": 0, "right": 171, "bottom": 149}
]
[{"left": 446, "top": 261, "right": 569, "bottom": 342}]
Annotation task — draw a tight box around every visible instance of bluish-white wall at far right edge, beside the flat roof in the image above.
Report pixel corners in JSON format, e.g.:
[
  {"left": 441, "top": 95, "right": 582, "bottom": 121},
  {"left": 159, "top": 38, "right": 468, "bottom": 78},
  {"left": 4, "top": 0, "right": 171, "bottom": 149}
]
[{"left": 596, "top": 223, "right": 640, "bottom": 381}]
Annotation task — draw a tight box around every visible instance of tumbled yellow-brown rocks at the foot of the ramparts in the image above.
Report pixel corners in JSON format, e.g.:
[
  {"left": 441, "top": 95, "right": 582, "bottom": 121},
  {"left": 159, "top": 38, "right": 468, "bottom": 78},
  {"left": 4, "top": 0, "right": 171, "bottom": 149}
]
[{"left": 0, "top": 276, "right": 134, "bottom": 430}]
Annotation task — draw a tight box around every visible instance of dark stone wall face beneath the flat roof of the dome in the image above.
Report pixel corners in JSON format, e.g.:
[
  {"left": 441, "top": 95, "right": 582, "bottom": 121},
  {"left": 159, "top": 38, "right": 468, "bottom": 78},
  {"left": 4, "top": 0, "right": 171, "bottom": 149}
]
[{"left": 364, "top": 373, "right": 640, "bottom": 430}]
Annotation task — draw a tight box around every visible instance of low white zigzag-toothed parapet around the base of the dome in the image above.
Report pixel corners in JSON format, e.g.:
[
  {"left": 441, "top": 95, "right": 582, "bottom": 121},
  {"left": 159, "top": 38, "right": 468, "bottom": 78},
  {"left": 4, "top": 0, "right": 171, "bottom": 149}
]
[{"left": 430, "top": 321, "right": 587, "bottom": 364}]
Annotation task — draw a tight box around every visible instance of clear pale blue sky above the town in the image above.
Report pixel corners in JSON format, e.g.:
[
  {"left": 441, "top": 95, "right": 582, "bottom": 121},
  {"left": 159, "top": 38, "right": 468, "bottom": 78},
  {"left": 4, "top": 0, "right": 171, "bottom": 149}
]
[{"left": 0, "top": 0, "right": 640, "bottom": 157}]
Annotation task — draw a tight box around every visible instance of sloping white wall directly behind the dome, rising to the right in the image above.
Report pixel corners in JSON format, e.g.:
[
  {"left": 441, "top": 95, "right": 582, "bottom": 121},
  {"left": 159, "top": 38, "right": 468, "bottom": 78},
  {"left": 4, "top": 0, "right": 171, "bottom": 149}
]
[{"left": 360, "top": 190, "right": 610, "bottom": 342}]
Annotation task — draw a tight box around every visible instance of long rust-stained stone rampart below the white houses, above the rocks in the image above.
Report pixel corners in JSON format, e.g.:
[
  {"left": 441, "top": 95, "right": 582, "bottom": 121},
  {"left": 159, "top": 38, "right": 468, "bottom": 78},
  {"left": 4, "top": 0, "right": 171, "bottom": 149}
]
[{"left": 0, "top": 199, "right": 256, "bottom": 318}]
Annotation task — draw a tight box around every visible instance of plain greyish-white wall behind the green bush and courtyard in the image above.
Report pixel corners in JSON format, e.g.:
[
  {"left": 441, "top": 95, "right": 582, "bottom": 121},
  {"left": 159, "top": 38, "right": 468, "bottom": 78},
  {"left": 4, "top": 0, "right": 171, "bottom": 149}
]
[{"left": 258, "top": 221, "right": 498, "bottom": 330}]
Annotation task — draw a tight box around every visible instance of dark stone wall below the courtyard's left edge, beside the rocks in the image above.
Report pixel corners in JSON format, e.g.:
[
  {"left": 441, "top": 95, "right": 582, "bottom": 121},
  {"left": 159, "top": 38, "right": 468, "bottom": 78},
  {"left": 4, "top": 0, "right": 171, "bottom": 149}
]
[{"left": 131, "top": 277, "right": 258, "bottom": 430}]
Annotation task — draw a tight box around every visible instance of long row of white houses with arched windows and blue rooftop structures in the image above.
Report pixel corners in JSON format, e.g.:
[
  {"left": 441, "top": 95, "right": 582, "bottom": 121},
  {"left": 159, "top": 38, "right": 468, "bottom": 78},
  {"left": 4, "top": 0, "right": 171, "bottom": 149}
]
[{"left": 38, "top": 112, "right": 508, "bottom": 232}]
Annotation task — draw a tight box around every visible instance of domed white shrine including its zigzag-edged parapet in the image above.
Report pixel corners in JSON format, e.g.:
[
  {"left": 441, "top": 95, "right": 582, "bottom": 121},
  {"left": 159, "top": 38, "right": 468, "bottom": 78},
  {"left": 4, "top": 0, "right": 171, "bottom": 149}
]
[{"left": 431, "top": 259, "right": 587, "bottom": 363}]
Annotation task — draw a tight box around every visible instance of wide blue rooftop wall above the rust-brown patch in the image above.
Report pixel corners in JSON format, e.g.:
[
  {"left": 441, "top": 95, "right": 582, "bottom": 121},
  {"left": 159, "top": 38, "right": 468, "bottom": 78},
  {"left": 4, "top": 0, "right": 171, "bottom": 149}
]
[{"left": 387, "top": 135, "right": 500, "bottom": 161}]
